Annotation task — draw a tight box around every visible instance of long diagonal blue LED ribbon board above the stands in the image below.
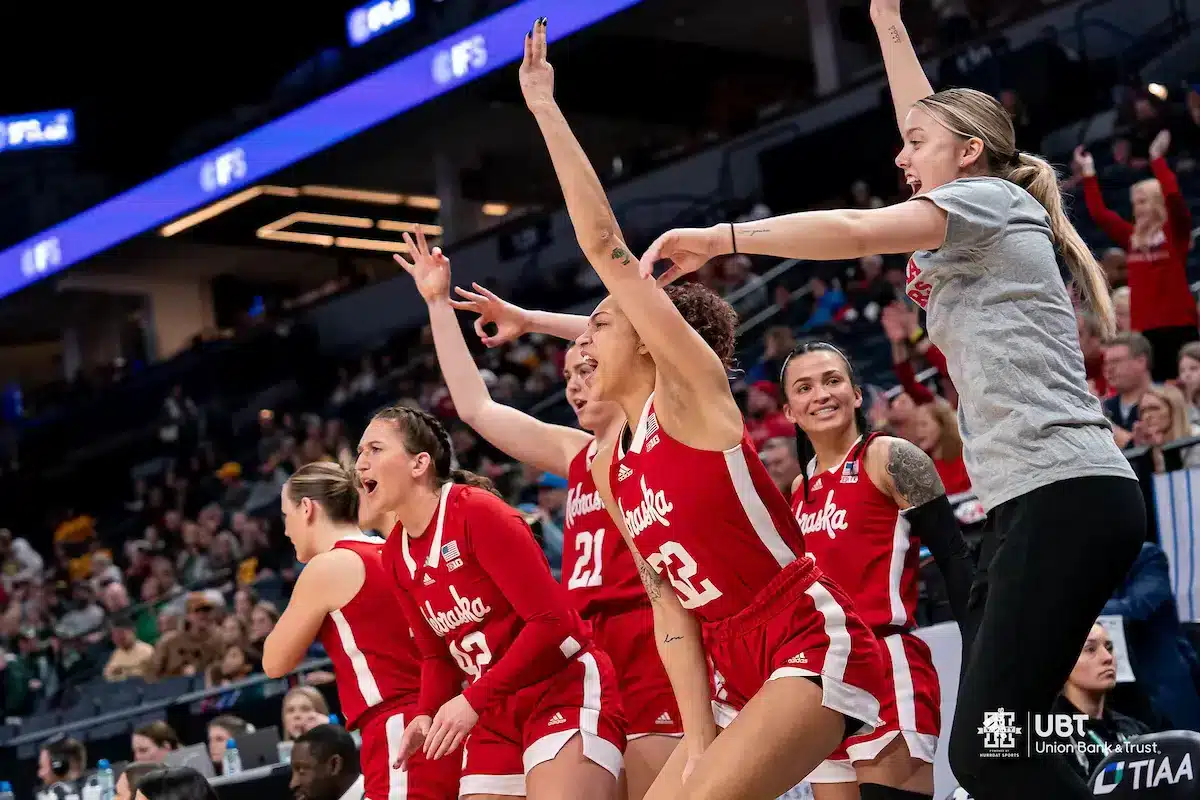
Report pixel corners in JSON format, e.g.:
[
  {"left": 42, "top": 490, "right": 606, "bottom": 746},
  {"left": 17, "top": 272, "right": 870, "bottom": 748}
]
[{"left": 0, "top": 0, "right": 642, "bottom": 297}]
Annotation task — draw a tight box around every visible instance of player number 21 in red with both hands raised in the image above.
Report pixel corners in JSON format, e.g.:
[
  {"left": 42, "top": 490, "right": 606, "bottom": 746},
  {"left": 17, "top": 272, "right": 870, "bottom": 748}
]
[{"left": 396, "top": 231, "right": 683, "bottom": 800}]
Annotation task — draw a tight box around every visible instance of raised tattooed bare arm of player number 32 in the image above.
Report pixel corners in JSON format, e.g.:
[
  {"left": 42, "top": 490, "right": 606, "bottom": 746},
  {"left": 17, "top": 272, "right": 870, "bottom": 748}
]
[{"left": 521, "top": 19, "right": 732, "bottom": 403}]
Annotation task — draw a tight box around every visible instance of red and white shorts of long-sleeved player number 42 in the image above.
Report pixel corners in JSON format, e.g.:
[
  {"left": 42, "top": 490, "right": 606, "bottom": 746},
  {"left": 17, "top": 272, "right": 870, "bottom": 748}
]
[{"left": 458, "top": 649, "right": 625, "bottom": 796}]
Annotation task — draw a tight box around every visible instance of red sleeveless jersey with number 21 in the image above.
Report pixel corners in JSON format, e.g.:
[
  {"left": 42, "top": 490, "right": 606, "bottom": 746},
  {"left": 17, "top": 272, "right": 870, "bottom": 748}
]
[{"left": 563, "top": 439, "right": 650, "bottom": 618}]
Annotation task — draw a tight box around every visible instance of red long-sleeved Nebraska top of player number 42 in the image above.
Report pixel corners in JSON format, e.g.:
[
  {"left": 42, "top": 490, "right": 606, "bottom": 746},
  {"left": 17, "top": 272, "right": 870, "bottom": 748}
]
[{"left": 384, "top": 483, "right": 592, "bottom": 712}]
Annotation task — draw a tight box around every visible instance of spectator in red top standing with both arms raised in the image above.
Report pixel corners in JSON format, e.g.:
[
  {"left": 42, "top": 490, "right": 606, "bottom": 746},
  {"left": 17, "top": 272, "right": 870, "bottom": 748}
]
[{"left": 1075, "top": 131, "right": 1200, "bottom": 381}]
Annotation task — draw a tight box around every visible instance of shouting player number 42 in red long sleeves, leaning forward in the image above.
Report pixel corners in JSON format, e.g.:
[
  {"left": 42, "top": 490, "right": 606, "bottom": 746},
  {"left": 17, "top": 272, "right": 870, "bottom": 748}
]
[{"left": 356, "top": 405, "right": 625, "bottom": 800}]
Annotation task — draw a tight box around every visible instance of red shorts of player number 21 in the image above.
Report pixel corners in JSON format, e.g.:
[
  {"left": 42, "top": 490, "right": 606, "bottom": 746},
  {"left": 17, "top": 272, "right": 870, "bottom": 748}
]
[{"left": 588, "top": 606, "right": 683, "bottom": 740}]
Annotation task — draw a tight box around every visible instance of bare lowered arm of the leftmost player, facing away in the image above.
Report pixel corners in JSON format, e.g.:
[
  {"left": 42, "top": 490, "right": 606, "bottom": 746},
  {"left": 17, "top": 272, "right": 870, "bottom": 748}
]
[{"left": 263, "top": 549, "right": 367, "bottom": 678}]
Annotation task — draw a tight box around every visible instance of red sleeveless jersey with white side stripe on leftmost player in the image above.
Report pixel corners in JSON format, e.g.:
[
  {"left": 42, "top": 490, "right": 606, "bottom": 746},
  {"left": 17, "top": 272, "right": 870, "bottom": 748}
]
[{"left": 318, "top": 536, "right": 421, "bottom": 728}]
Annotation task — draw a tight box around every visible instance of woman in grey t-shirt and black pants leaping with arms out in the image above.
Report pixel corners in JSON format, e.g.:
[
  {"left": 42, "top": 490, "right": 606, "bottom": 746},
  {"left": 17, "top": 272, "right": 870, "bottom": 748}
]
[{"left": 642, "top": 0, "right": 1146, "bottom": 800}]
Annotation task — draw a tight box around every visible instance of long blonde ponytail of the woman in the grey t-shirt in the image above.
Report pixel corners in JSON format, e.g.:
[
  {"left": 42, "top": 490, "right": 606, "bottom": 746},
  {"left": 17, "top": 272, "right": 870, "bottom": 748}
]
[{"left": 1004, "top": 152, "right": 1117, "bottom": 338}]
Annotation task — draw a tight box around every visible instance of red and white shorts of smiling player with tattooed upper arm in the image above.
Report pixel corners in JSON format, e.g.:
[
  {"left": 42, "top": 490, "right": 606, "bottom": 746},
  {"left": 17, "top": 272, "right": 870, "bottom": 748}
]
[{"left": 808, "top": 633, "right": 942, "bottom": 783}]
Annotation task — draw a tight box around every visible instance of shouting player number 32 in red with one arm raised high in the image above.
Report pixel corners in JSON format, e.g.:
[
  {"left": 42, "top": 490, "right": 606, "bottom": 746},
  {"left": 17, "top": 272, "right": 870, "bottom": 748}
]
[{"left": 521, "top": 19, "right": 883, "bottom": 800}]
